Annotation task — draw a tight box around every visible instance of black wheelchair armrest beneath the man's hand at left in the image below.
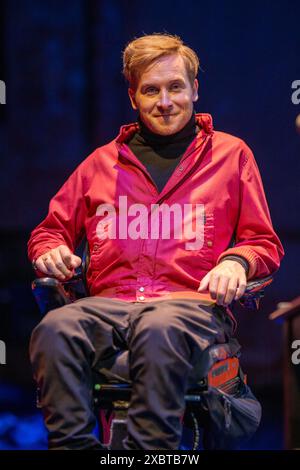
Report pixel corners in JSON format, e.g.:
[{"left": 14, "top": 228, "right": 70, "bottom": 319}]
[{"left": 31, "top": 272, "right": 88, "bottom": 315}]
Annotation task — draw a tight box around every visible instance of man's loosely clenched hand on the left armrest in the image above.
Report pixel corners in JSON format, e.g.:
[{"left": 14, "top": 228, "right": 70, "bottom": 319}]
[{"left": 34, "top": 245, "right": 81, "bottom": 281}]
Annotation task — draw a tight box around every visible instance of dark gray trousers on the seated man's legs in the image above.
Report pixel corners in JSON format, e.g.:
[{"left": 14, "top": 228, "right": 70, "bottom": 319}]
[{"left": 30, "top": 297, "right": 237, "bottom": 450}]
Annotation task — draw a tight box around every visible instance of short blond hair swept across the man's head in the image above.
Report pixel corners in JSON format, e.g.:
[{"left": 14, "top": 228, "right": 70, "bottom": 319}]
[{"left": 122, "top": 33, "right": 199, "bottom": 90}]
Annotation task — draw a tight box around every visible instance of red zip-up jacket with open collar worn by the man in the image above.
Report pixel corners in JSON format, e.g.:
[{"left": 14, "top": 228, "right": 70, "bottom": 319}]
[{"left": 28, "top": 114, "right": 284, "bottom": 301}]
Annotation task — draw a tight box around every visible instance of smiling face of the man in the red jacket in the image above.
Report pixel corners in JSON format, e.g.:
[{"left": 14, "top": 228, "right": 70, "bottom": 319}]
[{"left": 128, "top": 55, "right": 198, "bottom": 135}]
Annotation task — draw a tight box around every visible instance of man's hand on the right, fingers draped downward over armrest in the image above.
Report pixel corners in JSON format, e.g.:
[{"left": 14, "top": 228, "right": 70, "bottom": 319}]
[{"left": 198, "top": 260, "right": 247, "bottom": 307}]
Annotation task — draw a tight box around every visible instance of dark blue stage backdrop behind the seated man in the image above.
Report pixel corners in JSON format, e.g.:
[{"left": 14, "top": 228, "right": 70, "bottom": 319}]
[{"left": 0, "top": 0, "right": 300, "bottom": 449}]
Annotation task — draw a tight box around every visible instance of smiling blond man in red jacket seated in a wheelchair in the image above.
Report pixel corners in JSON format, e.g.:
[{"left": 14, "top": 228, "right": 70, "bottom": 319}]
[{"left": 28, "top": 34, "right": 283, "bottom": 449}]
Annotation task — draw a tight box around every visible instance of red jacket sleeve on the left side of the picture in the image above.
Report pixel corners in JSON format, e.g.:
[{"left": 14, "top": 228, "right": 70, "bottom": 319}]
[{"left": 27, "top": 165, "right": 86, "bottom": 268}]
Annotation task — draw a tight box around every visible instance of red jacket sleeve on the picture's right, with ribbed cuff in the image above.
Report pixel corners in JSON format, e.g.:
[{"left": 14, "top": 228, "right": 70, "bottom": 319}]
[{"left": 217, "top": 144, "right": 284, "bottom": 279}]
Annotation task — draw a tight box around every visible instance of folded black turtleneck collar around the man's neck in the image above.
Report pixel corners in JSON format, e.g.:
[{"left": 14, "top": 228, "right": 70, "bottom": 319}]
[{"left": 137, "top": 111, "right": 197, "bottom": 145}]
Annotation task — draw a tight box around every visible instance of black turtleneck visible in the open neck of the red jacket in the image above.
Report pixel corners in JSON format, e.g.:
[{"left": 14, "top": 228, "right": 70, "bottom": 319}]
[{"left": 127, "top": 112, "right": 199, "bottom": 192}]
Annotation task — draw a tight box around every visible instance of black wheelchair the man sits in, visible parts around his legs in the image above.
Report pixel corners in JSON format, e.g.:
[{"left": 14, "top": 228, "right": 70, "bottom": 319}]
[{"left": 32, "top": 243, "right": 273, "bottom": 450}]
